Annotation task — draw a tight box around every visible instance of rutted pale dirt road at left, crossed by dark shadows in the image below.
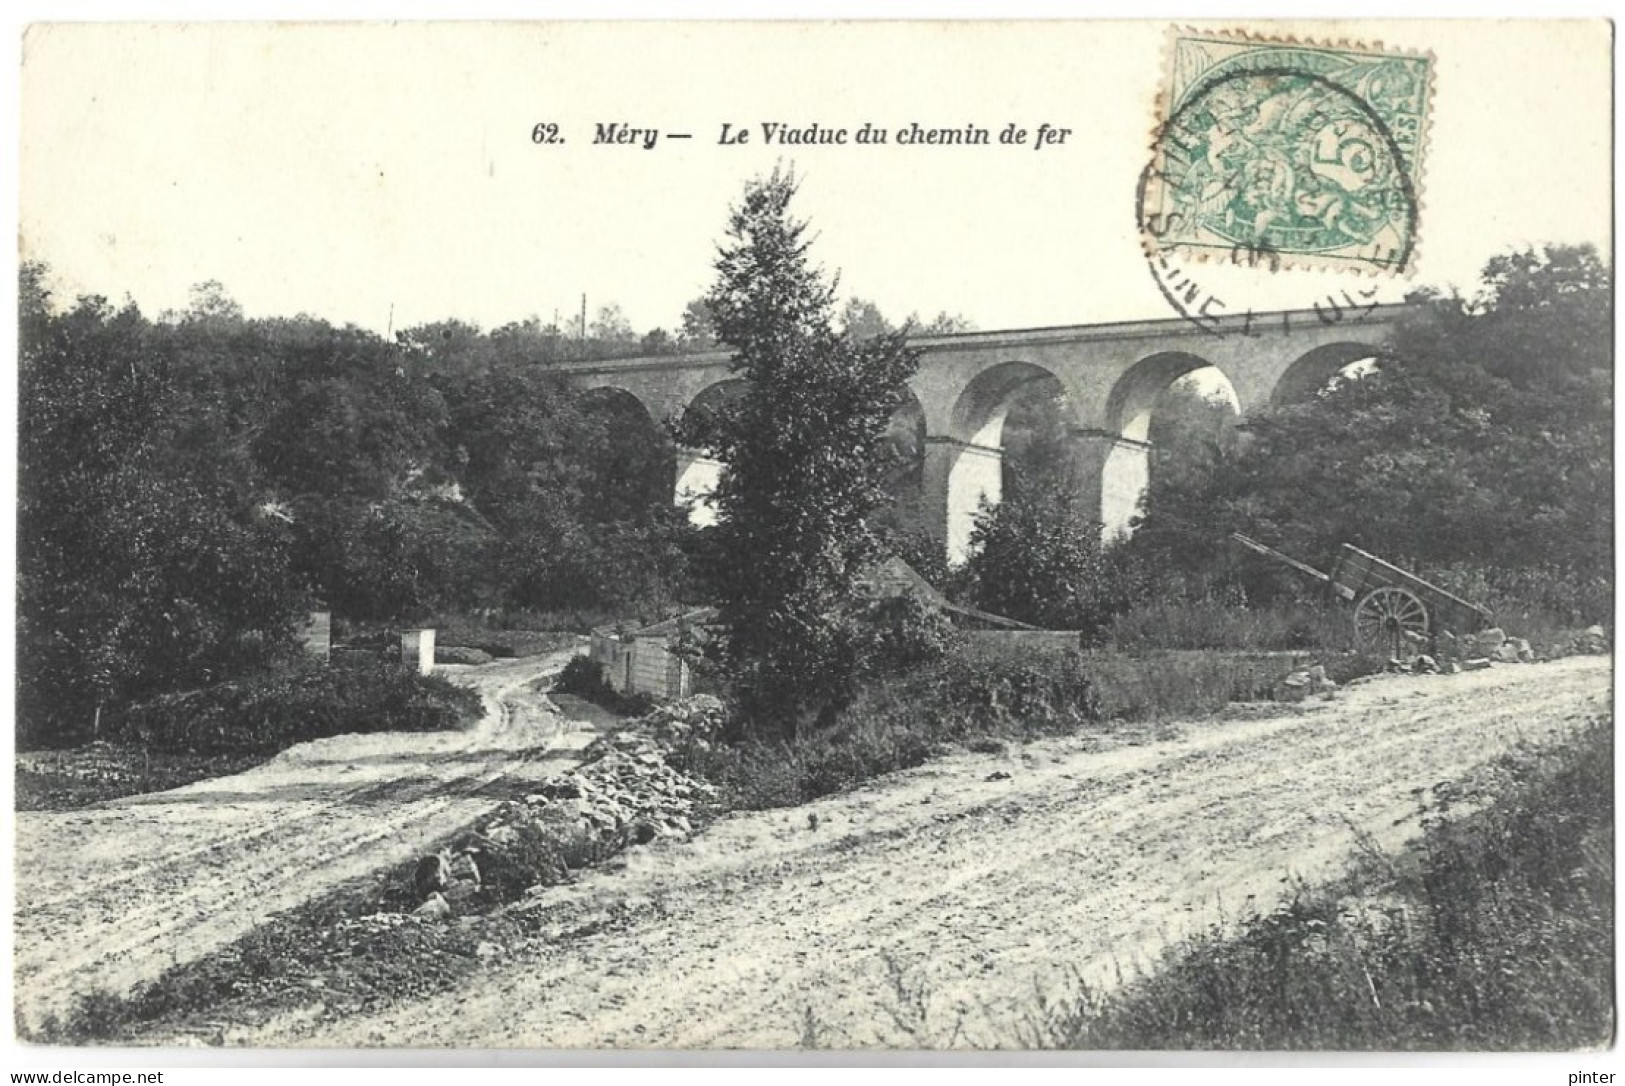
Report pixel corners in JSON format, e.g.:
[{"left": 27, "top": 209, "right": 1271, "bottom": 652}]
[{"left": 15, "top": 650, "right": 593, "bottom": 1024}]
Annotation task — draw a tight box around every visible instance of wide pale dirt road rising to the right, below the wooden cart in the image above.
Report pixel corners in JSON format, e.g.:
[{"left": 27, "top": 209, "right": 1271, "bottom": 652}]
[{"left": 228, "top": 657, "right": 1610, "bottom": 1047}]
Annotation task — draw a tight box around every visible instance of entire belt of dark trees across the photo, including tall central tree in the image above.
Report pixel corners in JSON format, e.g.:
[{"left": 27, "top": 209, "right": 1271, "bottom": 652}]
[{"left": 18, "top": 238, "right": 1614, "bottom": 738}]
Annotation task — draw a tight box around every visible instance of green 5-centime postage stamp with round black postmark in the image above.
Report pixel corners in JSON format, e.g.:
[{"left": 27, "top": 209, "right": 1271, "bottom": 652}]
[{"left": 1139, "top": 29, "right": 1433, "bottom": 273}]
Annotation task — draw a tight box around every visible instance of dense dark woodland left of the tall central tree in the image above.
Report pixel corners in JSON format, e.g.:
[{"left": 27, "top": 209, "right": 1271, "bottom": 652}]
[{"left": 18, "top": 265, "right": 689, "bottom": 736}]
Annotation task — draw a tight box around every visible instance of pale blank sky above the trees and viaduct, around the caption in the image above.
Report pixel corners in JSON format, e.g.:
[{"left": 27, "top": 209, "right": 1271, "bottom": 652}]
[{"left": 21, "top": 21, "right": 1612, "bottom": 332}]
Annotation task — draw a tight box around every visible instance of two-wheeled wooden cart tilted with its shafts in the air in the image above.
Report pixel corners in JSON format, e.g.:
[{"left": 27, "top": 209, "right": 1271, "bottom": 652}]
[{"left": 1230, "top": 532, "right": 1495, "bottom": 655}]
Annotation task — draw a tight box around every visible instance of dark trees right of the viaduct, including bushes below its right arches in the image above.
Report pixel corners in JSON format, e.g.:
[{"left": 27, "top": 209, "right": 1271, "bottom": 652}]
[{"left": 964, "top": 247, "right": 1614, "bottom": 629}]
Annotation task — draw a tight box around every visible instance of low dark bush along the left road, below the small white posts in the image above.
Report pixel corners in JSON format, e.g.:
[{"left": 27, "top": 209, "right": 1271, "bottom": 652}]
[{"left": 119, "top": 660, "right": 481, "bottom": 754}]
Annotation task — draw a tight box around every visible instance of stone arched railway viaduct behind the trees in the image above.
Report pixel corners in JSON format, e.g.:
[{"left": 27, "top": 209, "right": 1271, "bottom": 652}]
[{"left": 561, "top": 306, "right": 1409, "bottom": 561}]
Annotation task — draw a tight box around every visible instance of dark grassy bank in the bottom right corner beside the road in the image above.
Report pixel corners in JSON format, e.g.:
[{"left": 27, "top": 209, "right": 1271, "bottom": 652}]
[{"left": 1042, "top": 708, "right": 1614, "bottom": 1050}]
